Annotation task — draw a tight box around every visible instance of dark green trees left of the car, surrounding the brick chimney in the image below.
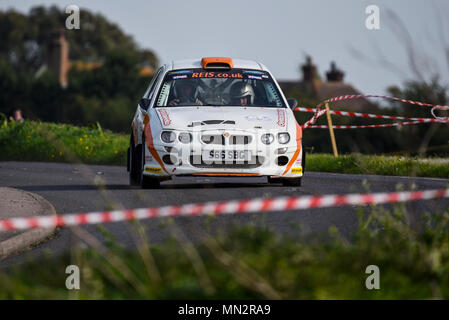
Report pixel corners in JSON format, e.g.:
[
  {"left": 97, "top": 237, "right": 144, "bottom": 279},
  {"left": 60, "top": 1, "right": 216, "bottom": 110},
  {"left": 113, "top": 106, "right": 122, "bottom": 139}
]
[{"left": 0, "top": 6, "right": 157, "bottom": 132}]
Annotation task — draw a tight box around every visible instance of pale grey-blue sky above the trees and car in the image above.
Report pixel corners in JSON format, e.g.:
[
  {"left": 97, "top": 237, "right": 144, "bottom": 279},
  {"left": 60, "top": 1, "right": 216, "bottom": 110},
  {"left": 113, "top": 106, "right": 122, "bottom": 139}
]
[{"left": 0, "top": 0, "right": 449, "bottom": 94}]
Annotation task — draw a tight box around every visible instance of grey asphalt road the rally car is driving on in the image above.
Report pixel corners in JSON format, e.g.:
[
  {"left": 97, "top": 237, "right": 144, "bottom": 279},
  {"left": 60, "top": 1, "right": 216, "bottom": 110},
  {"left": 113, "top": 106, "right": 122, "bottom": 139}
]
[{"left": 0, "top": 162, "right": 449, "bottom": 266}]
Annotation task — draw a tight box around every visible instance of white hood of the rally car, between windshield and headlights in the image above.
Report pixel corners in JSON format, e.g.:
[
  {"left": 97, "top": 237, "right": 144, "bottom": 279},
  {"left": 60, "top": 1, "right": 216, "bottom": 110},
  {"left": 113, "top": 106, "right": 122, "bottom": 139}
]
[{"left": 156, "top": 107, "right": 288, "bottom": 130}]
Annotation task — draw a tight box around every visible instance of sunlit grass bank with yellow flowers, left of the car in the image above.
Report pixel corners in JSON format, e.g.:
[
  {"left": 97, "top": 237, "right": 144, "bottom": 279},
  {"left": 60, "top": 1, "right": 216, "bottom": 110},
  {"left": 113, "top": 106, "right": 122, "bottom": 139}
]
[{"left": 0, "top": 121, "right": 129, "bottom": 165}]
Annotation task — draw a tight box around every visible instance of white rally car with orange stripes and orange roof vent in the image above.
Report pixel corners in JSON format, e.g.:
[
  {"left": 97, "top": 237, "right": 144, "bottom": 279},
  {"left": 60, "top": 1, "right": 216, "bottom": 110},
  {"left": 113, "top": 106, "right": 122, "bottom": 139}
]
[{"left": 127, "top": 58, "right": 305, "bottom": 188}]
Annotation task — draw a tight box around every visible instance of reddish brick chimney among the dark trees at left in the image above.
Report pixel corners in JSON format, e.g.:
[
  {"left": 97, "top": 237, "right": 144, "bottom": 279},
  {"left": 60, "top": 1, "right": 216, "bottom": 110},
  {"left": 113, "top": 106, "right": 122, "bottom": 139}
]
[{"left": 46, "top": 29, "right": 69, "bottom": 88}]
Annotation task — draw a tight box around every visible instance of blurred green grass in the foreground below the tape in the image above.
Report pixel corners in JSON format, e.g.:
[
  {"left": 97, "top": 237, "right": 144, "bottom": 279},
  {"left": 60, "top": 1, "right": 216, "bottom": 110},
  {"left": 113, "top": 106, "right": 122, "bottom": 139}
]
[{"left": 0, "top": 205, "right": 449, "bottom": 299}]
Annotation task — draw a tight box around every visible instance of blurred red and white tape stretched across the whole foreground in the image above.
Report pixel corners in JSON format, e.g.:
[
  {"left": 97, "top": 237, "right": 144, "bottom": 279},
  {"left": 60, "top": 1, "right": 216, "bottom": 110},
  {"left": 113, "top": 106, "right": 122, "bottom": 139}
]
[{"left": 0, "top": 189, "right": 449, "bottom": 231}]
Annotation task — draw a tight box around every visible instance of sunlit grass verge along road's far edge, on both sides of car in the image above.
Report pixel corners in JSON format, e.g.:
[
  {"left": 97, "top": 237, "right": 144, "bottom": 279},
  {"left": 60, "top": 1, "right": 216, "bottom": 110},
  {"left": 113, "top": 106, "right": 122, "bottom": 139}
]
[{"left": 0, "top": 120, "right": 449, "bottom": 178}]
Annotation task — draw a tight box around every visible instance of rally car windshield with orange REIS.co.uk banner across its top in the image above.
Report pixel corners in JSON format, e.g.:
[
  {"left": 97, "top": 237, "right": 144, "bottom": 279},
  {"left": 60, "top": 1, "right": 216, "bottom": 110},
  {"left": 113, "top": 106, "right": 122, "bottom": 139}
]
[{"left": 156, "top": 69, "right": 285, "bottom": 108}]
